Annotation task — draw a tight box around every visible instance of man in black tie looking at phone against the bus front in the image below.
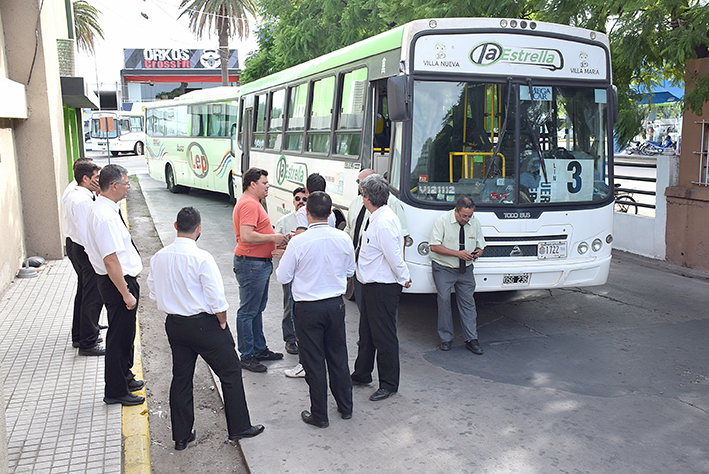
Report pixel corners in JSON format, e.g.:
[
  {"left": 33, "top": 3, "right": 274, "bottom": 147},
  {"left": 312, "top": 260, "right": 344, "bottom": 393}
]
[{"left": 429, "top": 196, "right": 485, "bottom": 354}]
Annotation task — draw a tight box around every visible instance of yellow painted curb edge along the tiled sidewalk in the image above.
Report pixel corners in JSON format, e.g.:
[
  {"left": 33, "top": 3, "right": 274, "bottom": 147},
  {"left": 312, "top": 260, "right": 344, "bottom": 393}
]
[{"left": 123, "top": 314, "right": 151, "bottom": 474}]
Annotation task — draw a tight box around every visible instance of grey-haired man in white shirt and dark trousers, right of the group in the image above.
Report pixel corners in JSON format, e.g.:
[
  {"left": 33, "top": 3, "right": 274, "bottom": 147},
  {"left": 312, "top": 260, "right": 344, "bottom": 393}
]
[{"left": 352, "top": 174, "right": 411, "bottom": 401}]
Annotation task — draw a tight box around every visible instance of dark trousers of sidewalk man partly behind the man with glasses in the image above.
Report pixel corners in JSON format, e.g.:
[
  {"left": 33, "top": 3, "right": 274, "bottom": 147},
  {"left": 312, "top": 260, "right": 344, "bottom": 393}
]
[{"left": 66, "top": 237, "right": 103, "bottom": 349}]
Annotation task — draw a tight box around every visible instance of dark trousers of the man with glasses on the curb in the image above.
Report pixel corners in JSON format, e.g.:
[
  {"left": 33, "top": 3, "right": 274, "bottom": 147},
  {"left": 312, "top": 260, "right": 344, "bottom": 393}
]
[{"left": 98, "top": 275, "right": 140, "bottom": 398}]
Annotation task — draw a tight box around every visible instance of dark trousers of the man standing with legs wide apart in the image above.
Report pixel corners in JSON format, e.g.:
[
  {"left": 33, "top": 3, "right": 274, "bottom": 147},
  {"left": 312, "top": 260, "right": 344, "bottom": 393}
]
[{"left": 165, "top": 313, "right": 251, "bottom": 441}]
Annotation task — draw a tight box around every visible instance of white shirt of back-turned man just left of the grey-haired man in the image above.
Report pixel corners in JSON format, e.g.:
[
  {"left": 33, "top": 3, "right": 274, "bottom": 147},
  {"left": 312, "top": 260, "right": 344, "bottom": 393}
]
[{"left": 276, "top": 222, "right": 355, "bottom": 301}]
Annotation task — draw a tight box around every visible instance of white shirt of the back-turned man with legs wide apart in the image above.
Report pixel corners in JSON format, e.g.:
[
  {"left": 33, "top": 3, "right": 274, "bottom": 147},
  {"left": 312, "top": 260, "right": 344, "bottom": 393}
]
[{"left": 148, "top": 237, "right": 229, "bottom": 316}]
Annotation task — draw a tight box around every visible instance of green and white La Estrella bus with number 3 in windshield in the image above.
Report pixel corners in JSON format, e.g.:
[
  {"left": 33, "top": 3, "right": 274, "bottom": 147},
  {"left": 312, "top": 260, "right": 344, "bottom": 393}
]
[{"left": 232, "top": 18, "right": 617, "bottom": 293}]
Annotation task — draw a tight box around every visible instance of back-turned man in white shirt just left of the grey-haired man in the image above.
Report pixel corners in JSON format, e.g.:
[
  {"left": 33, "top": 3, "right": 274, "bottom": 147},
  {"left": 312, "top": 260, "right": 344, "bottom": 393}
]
[{"left": 276, "top": 191, "right": 355, "bottom": 428}]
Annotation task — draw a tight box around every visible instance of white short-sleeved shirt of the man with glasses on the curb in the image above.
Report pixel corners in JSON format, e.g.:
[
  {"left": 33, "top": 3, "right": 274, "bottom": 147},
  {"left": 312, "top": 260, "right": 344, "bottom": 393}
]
[{"left": 84, "top": 196, "right": 143, "bottom": 277}]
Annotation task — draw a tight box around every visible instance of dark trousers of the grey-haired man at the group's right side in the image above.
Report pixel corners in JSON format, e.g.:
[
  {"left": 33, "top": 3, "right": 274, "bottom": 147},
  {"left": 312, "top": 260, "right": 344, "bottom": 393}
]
[{"left": 352, "top": 283, "right": 401, "bottom": 392}]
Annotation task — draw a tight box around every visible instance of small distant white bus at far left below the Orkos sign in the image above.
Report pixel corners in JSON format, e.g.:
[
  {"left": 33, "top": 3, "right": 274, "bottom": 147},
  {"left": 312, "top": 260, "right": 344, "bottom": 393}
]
[{"left": 91, "top": 110, "right": 145, "bottom": 156}]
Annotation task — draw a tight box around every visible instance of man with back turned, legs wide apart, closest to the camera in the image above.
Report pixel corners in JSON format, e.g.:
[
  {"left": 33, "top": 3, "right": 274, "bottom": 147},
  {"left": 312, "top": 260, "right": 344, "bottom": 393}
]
[{"left": 148, "top": 207, "right": 264, "bottom": 451}]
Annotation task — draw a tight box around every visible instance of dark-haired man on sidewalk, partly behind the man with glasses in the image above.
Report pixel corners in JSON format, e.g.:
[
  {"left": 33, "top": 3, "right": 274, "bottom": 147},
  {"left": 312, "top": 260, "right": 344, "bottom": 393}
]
[{"left": 62, "top": 160, "right": 105, "bottom": 356}]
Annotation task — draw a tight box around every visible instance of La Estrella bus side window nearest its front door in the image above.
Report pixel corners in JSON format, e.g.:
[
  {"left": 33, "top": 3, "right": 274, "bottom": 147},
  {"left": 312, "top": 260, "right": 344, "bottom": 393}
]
[{"left": 335, "top": 68, "right": 367, "bottom": 155}]
